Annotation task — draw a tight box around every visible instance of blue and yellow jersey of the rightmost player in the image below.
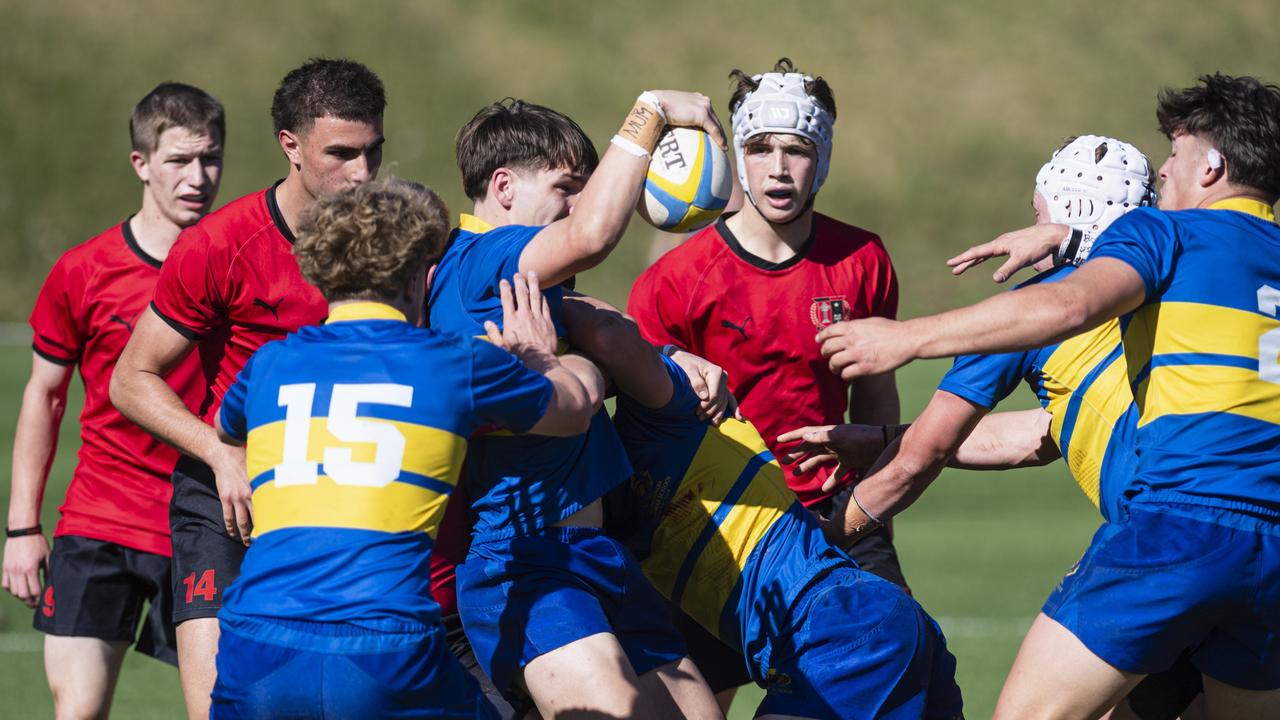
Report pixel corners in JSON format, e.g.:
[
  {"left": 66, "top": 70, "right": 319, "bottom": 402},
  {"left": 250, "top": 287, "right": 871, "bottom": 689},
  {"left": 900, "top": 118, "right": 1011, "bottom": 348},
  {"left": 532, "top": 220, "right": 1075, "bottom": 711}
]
[{"left": 1089, "top": 199, "right": 1280, "bottom": 511}]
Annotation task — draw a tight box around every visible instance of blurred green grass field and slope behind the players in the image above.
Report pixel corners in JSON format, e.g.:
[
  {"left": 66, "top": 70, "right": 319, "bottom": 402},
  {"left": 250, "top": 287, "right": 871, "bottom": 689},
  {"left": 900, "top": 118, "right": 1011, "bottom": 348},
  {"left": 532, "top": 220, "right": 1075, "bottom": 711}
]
[{"left": 0, "top": 0, "right": 1280, "bottom": 717}]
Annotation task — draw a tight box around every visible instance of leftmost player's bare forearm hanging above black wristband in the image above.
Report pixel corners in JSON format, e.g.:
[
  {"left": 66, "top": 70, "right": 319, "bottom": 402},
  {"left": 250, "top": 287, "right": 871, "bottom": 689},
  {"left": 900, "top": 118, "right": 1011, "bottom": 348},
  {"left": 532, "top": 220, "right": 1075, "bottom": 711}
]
[{"left": 8, "top": 386, "right": 67, "bottom": 528}]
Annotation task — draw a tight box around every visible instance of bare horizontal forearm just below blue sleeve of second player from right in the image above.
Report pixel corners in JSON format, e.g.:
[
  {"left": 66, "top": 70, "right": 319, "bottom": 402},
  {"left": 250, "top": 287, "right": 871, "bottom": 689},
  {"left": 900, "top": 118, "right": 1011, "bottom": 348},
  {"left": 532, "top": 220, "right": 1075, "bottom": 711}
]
[{"left": 950, "top": 409, "right": 1061, "bottom": 470}]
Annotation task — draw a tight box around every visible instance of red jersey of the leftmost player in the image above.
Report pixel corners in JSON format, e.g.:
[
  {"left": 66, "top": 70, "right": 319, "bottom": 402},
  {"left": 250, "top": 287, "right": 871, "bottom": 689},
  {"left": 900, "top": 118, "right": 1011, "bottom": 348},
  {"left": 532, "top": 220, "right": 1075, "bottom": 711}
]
[{"left": 31, "top": 222, "right": 204, "bottom": 556}]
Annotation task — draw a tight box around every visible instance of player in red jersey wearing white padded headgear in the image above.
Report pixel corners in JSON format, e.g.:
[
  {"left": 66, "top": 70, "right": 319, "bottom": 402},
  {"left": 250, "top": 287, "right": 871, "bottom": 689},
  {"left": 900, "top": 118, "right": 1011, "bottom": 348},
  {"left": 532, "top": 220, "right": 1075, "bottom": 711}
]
[{"left": 627, "top": 58, "right": 906, "bottom": 707}]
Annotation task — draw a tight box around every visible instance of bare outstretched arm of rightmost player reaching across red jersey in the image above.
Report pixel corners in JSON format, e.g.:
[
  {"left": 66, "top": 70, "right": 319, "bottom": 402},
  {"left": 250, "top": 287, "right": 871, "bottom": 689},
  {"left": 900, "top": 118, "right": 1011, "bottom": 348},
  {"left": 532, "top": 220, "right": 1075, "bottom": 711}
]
[{"left": 818, "top": 258, "right": 1146, "bottom": 380}]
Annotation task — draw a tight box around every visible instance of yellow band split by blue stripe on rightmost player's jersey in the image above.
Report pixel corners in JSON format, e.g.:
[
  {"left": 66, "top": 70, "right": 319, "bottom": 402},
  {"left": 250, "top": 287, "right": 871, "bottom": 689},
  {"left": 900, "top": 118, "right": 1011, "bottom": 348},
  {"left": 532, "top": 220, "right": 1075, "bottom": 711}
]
[{"left": 1125, "top": 302, "right": 1280, "bottom": 427}]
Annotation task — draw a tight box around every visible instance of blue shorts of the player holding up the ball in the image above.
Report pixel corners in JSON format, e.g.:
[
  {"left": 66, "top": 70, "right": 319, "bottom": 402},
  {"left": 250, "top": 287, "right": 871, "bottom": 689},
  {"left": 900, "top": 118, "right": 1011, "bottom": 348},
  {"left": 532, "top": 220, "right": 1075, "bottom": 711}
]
[{"left": 458, "top": 528, "right": 686, "bottom": 692}]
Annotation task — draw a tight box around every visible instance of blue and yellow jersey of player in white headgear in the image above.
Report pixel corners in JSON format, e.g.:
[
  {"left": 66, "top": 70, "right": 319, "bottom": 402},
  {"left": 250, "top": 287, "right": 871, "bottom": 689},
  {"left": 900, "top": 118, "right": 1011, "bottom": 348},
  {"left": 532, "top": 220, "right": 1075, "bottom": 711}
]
[{"left": 938, "top": 265, "right": 1138, "bottom": 519}]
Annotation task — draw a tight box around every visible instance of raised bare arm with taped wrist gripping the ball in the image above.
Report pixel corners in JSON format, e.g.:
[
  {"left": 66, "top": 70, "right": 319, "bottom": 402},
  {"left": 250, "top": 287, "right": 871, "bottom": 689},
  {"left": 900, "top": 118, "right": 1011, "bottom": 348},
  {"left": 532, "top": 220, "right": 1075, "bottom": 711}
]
[{"left": 520, "top": 90, "right": 727, "bottom": 287}]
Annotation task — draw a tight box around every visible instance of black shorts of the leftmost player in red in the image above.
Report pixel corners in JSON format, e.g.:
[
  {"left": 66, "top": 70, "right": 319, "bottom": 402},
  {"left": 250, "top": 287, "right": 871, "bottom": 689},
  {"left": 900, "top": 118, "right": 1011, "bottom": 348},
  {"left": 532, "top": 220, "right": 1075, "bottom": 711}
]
[{"left": 35, "top": 536, "right": 178, "bottom": 665}]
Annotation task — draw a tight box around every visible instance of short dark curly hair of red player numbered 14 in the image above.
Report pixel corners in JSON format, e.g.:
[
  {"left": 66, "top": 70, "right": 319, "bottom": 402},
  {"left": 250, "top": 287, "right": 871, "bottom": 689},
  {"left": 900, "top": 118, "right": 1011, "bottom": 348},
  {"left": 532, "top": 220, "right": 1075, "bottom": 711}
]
[{"left": 271, "top": 58, "right": 387, "bottom": 132}]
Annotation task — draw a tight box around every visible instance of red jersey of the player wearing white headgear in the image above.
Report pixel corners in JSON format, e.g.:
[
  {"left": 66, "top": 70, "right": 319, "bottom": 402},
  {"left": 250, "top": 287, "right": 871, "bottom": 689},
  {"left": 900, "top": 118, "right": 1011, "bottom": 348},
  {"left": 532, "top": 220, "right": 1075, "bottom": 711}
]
[{"left": 627, "top": 213, "right": 897, "bottom": 505}]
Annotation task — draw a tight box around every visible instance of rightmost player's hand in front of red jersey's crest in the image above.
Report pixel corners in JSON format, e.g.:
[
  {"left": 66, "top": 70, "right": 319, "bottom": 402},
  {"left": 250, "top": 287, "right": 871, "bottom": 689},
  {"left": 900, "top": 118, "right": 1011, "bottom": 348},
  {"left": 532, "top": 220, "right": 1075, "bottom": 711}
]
[{"left": 818, "top": 318, "right": 916, "bottom": 380}]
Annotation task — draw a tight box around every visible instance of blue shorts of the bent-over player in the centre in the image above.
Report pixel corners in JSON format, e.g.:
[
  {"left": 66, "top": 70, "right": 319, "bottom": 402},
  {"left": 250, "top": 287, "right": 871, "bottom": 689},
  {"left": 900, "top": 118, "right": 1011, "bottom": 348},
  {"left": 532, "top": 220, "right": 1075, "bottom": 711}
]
[{"left": 753, "top": 568, "right": 963, "bottom": 720}]
